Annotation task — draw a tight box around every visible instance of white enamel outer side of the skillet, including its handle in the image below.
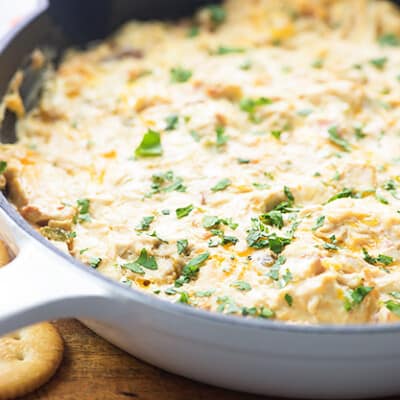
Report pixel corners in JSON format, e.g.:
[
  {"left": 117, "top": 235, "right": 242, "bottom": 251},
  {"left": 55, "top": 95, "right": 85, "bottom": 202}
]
[{"left": 0, "top": 205, "right": 400, "bottom": 399}]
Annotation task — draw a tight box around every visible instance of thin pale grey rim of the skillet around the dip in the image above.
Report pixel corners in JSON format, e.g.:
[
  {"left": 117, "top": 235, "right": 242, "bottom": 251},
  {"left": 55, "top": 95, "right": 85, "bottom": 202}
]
[{"left": 0, "top": 0, "right": 400, "bottom": 335}]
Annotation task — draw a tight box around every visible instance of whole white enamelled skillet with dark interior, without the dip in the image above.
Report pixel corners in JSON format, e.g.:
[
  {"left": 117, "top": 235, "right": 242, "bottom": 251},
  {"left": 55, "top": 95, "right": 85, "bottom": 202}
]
[{"left": 0, "top": 0, "right": 400, "bottom": 399}]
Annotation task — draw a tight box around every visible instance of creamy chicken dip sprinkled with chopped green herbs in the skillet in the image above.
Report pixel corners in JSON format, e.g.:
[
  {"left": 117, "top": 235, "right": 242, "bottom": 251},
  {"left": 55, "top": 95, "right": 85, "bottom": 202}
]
[{"left": 0, "top": 0, "right": 400, "bottom": 324}]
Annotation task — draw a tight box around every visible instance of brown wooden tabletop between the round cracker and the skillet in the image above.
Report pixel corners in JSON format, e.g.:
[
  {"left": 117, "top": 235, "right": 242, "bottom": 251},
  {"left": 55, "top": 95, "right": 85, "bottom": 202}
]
[{"left": 23, "top": 320, "right": 261, "bottom": 400}]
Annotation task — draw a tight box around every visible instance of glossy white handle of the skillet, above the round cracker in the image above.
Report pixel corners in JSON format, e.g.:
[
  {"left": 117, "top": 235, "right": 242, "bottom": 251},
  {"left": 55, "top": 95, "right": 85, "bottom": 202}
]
[{"left": 0, "top": 208, "right": 115, "bottom": 335}]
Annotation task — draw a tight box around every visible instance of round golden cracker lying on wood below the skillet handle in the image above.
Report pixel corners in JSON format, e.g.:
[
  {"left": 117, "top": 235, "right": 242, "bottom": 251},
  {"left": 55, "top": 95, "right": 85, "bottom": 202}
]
[{"left": 0, "top": 322, "right": 64, "bottom": 400}]
